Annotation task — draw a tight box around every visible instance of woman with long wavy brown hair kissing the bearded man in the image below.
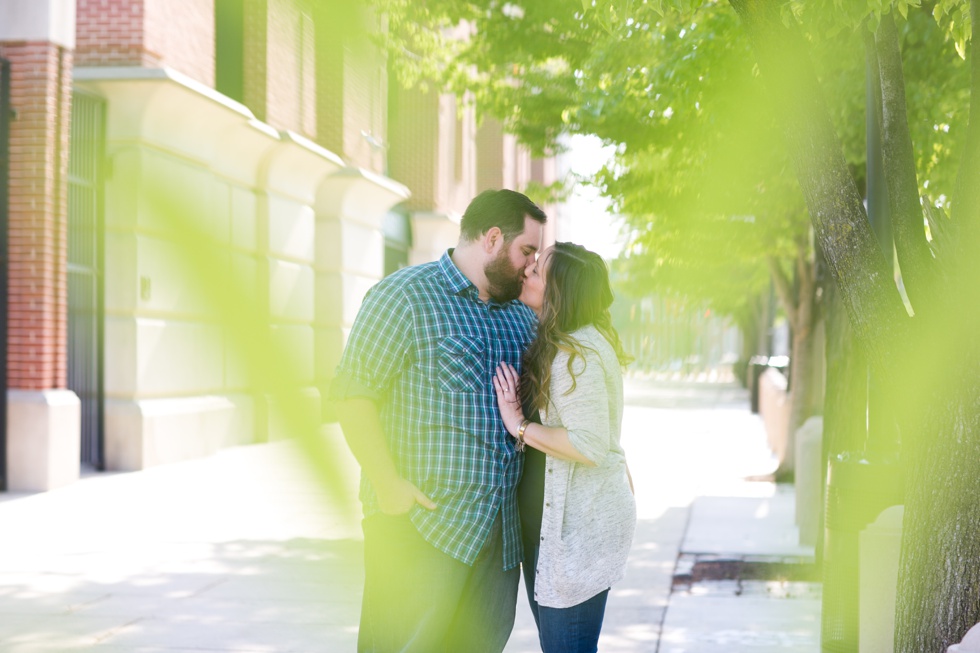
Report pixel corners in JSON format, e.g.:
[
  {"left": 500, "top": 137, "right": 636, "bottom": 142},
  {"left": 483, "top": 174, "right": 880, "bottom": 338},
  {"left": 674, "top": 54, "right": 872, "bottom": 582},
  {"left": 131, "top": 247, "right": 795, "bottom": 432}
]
[{"left": 494, "top": 243, "right": 636, "bottom": 653}]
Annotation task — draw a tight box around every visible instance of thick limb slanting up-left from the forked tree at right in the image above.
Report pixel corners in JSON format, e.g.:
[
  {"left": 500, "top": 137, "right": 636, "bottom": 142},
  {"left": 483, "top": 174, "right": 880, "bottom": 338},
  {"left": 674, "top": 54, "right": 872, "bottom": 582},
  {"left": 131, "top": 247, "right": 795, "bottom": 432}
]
[{"left": 729, "top": 0, "right": 908, "bottom": 366}]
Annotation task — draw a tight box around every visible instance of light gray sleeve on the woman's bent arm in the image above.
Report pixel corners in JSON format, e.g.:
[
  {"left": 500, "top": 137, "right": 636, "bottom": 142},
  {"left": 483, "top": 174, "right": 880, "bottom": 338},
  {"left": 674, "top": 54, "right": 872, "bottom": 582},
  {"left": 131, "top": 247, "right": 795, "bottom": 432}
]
[{"left": 551, "top": 345, "right": 610, "bottom": 465}]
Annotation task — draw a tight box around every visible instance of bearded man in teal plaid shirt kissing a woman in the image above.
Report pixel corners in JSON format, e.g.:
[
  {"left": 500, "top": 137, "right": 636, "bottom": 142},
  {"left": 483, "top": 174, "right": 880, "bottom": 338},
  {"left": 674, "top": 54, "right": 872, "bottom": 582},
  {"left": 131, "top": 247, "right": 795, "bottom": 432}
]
[{"left": 330, "top": 190, "right": 547, "bottom": 653}]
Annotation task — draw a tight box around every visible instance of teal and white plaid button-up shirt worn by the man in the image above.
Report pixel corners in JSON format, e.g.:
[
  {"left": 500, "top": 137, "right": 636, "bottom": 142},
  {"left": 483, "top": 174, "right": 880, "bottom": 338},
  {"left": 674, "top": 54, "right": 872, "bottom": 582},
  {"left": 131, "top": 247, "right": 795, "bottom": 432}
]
[{"left": 330, "top": 250, "right": 535, "bottom": 569}]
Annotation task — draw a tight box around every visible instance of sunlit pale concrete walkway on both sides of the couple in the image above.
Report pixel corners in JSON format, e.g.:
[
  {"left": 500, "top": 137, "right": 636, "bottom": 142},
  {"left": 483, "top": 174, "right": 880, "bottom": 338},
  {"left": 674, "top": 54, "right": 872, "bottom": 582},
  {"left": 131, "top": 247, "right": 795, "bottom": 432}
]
[{"left": 0, "top": 380, "right": 819, "bottom": 653}]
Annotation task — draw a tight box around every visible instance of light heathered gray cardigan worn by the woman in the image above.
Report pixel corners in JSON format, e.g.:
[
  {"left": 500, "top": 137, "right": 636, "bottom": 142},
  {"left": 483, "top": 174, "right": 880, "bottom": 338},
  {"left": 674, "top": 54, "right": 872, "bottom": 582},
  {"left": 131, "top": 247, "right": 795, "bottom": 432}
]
[{"left": 534, "top": 326, "right": 636, "bottom": 608}]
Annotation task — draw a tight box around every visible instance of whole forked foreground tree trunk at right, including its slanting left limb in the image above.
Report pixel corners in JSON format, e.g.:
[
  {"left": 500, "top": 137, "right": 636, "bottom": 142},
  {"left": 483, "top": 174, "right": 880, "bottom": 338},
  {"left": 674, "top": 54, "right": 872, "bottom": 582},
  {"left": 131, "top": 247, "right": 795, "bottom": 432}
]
[{"left": 730, "top": 0, "right": 980, "bottom": 653}]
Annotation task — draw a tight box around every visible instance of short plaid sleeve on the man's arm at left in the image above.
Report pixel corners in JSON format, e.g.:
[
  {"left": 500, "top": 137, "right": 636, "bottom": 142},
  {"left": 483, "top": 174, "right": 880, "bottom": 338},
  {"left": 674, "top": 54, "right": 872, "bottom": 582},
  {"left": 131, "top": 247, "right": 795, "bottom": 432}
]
[{"left": 330, "top": 282, "right": 412, "bottom": 403}]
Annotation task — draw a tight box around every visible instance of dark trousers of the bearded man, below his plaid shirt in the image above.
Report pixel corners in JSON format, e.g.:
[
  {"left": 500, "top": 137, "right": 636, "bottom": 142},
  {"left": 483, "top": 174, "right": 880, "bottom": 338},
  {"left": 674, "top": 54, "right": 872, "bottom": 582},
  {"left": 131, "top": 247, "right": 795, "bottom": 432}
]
[{"left": 357, "top": 514, "right": 520, "bottom": 653}]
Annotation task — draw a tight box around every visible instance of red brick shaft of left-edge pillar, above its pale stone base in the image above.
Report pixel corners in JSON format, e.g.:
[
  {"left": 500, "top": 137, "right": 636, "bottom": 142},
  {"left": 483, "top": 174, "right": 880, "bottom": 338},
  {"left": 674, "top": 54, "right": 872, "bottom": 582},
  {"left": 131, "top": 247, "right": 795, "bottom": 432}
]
[{"left": 0, "top": 42, "right": 72, "bottom": 390}]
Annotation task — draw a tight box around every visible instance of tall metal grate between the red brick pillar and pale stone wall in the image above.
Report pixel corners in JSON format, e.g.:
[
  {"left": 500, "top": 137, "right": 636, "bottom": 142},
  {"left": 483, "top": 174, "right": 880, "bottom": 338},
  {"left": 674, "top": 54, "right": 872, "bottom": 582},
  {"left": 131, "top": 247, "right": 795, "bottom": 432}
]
[{"left": 68, "top": 91, "right": 105, "bottom": 470}]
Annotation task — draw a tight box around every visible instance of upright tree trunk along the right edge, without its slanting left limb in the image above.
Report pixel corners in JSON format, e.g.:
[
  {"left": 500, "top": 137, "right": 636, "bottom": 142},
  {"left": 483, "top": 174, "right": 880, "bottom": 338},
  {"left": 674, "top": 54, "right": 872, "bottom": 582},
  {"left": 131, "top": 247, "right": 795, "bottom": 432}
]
[{"left": 895, "top": 0, "right": 980, "bottom": 653}]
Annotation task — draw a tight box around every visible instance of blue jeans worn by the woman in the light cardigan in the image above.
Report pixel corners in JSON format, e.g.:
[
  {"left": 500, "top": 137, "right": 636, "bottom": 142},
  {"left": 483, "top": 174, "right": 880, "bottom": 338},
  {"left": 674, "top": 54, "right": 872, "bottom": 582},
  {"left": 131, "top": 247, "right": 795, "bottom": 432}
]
[{"left": 523, "top": 546, "right": 609, "bottom": 653}]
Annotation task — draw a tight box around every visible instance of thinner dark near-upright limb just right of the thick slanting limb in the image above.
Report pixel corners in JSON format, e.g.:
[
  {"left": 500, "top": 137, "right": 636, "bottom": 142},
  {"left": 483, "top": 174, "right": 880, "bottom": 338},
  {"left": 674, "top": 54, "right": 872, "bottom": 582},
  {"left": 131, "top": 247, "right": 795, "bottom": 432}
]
[{"left": 869, "top": 14, "right": 935, "bottom": 312}]
